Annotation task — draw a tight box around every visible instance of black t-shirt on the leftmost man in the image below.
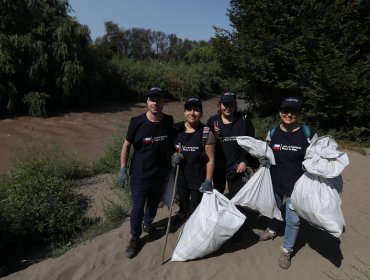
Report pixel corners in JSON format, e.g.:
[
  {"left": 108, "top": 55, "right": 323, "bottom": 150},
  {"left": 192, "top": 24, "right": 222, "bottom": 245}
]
[{"left": 126, "top": 113, "right": 173, "bottom": 181}]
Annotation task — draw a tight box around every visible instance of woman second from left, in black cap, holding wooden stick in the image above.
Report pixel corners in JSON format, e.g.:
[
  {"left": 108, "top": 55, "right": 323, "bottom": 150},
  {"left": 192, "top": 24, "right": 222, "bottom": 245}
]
[{"left": 174, "top": 97, "right": 215, "bottom": 224}]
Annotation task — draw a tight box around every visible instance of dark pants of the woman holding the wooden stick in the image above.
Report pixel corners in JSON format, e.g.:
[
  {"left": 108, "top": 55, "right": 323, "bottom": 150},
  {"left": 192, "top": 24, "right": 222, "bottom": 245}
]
[{"left": 178, "top": 185, "right": 203, "bottom": 215}]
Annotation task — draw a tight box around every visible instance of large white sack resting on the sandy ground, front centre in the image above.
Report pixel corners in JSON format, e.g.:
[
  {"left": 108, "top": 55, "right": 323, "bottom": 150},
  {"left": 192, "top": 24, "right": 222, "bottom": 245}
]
[{"left": 171, "top": 190, "right": 245, "bottom": 261}]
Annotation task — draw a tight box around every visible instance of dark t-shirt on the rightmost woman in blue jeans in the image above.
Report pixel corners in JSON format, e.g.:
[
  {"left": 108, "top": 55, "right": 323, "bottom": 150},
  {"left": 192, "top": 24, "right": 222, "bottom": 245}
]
[{"left": 267, "top": 126, "right": 316, "bottom": 196}]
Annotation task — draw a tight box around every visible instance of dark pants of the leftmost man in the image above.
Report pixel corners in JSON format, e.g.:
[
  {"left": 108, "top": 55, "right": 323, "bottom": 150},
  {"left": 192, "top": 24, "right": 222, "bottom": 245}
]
[{"left": 130, "top": 181, "right": 164, "bottom": 237}]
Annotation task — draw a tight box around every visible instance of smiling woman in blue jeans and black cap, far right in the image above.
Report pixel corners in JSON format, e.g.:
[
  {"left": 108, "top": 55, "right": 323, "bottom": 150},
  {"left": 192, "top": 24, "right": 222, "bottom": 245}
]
[{"left": 259, "top": 96, "right": 316, "bottom": 269}]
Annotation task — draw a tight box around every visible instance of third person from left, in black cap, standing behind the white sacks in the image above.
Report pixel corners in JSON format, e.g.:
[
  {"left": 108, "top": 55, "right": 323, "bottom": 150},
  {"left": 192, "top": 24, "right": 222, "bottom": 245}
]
[{"left": 207, "top": 92, "right": 258, "bottom": 198}]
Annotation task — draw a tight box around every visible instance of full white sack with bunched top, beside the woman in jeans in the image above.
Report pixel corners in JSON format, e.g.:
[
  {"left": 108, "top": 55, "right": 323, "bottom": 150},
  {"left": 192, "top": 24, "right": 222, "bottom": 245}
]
[{"left": 291, "top": 136, "right": 349, "bottom": 237}]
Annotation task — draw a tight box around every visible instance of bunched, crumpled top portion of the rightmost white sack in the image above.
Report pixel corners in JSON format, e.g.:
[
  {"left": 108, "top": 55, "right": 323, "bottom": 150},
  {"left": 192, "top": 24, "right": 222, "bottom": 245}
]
[{"left": 302, "top": 136, "right": 349, "bottom": 178}]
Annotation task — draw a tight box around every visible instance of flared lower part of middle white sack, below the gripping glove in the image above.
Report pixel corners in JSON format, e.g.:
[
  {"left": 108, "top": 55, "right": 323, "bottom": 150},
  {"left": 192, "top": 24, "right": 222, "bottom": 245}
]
[{"left": 231, "top": 167, "right": 283, "bottom": 221}]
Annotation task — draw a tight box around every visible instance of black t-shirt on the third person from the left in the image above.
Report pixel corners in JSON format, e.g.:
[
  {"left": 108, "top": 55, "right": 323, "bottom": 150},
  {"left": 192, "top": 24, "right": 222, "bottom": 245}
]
[{"left": 207, "top": 114, "right": 254, "bottom": 177}]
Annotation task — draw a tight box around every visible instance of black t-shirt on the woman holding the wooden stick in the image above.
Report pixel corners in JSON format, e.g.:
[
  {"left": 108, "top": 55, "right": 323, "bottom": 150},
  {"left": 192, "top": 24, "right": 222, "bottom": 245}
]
[{"left": 175, "top": 122, "right": 214, "bottom": 189}]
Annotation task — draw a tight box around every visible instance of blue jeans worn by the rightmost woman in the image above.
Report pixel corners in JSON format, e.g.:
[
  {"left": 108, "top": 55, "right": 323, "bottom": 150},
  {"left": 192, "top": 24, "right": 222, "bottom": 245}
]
[{"left": 268, "top": 193, "right": 300, "bottom": 251}]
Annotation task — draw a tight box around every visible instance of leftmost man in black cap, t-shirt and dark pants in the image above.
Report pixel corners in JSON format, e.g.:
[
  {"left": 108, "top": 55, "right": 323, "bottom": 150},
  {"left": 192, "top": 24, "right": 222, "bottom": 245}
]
[{"left": 118, "top": 88, "right": 173, "bottom": 258}]
